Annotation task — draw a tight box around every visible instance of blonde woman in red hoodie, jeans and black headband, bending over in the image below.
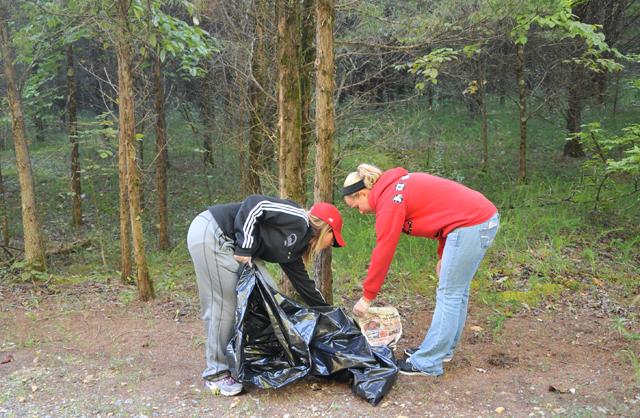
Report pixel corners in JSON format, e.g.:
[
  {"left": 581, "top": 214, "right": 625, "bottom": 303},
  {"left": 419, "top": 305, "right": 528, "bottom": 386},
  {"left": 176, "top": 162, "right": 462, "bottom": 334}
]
[{"left": 342, "top": 164, "right": 500, "bottom": 376}]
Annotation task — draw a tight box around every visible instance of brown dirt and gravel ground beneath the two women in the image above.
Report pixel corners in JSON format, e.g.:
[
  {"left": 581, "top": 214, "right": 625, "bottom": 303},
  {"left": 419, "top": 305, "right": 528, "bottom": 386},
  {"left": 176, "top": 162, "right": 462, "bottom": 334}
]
[{"left": 0, "top": 282, "right": 640, "bottom": 417}]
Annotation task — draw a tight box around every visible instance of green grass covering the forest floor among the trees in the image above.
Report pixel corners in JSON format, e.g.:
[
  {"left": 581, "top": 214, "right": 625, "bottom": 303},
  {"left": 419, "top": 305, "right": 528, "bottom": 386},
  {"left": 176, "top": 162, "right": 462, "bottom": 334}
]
[{"left": 0, "top": 92, "right": 640, "bottom": 331}]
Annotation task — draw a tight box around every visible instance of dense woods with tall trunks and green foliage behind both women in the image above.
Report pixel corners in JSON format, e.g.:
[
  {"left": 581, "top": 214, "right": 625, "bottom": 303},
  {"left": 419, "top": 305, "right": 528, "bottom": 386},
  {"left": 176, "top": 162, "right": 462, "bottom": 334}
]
[{"left": 0, "top": 0, "right": 640, "bottom": 300}]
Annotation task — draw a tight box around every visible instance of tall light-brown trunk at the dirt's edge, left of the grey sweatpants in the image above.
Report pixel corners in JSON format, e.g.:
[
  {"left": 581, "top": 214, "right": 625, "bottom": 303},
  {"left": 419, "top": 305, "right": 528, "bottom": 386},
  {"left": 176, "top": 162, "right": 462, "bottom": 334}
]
[{"left": 116, "top": 0, "right": 154, "bottom": 301}]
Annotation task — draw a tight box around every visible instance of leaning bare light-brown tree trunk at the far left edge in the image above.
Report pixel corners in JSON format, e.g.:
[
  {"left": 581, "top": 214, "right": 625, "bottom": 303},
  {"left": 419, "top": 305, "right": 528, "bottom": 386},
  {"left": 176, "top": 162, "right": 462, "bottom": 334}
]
[{"left": 0, "top": 4, "right": 46, "bottom": 270}]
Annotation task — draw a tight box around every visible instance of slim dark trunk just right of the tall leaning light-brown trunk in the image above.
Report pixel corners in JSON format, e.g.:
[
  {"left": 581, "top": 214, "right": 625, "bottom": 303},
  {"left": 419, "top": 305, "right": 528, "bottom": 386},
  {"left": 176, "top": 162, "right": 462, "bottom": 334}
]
[{"left": 153, "top": 54, "right": 171, "bottom": 250}]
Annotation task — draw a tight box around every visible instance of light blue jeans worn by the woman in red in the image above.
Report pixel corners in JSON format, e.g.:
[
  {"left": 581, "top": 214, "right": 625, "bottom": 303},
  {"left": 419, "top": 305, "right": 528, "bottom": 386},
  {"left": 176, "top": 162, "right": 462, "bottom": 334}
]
[{"left": 410, "top": 213, "right": 500, "bottom": 376}]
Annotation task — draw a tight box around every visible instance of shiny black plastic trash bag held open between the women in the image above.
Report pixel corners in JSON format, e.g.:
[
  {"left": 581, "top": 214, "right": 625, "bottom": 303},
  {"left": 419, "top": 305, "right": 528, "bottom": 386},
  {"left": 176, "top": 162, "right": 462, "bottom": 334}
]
[{"left": 227, "top": 268, "right": 398, "bottom": 405}]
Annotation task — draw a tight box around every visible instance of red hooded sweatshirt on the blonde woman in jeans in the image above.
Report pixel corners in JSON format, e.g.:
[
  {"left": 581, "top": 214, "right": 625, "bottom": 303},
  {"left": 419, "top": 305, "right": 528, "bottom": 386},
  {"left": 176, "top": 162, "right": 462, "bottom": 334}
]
[{"left": 363, "top": 167, "right": 497, "bottom": 300}]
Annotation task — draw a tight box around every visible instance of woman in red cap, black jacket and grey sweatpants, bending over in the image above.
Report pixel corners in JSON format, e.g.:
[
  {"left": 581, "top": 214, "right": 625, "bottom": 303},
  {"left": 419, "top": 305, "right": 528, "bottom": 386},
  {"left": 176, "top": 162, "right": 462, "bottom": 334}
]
[{"left": 187, "top": 195, "right": 344, "bottom": 396}]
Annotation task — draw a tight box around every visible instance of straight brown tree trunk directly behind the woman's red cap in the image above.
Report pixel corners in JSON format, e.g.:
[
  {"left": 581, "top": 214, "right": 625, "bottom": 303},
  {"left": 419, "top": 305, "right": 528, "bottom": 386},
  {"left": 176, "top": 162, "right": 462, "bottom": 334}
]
[{"left": 313, "top": 0, "right": 335, "bottom": 304}]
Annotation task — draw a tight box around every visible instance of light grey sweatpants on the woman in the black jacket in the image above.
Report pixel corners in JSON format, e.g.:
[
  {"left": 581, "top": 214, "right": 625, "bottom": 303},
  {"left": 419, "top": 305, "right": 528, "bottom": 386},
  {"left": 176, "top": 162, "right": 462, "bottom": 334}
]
[{"left": 187, "top": 210, "right": 240, "bottom": 378}]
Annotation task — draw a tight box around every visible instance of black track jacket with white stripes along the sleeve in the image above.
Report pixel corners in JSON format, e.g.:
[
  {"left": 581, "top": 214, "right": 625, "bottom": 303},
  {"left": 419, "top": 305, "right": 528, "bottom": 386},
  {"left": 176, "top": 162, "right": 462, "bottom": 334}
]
[{"left": 209, "top": 195, "right": 328, "bottom": 306}]
